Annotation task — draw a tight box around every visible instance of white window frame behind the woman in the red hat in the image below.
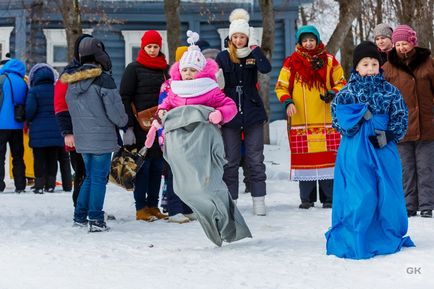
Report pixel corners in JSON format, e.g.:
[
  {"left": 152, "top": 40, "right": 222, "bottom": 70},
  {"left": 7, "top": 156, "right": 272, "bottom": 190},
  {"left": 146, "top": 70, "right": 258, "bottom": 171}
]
[{"left": 121, "top": 30, "right": 169, "bottom": 66}]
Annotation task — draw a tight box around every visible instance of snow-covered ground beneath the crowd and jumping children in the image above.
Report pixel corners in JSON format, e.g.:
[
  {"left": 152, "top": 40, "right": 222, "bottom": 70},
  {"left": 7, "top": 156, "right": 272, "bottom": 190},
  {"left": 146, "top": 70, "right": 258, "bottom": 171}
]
[{"left": 0, "top": 121, "right": 434, "bottom": 289}]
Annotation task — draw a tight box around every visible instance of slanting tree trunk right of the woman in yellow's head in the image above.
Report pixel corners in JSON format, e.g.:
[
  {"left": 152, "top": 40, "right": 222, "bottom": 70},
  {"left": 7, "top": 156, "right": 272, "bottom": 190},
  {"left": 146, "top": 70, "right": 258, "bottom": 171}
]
[{"left": 327, "top": 0, "right": 361, "bottom": 54}]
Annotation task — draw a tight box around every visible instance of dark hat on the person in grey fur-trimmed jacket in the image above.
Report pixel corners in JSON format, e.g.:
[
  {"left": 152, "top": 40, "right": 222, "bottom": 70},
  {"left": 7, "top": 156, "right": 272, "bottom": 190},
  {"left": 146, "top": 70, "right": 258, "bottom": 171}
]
[{"left": 78, "top": 37, "right": 112, "bottom": 71}]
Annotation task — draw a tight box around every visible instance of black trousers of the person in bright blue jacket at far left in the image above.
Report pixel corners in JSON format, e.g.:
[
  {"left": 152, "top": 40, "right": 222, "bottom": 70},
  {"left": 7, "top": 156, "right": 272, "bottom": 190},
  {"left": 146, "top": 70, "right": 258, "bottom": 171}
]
[{"left": 0, "top": 129, "right": 26, "bottom": 192}]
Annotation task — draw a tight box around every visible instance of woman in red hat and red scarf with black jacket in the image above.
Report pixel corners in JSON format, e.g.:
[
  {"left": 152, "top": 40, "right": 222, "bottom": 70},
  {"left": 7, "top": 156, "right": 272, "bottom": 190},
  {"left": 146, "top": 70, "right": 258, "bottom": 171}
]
[{"left": 120, "top": 30, "right": 168, "bottom": 222}]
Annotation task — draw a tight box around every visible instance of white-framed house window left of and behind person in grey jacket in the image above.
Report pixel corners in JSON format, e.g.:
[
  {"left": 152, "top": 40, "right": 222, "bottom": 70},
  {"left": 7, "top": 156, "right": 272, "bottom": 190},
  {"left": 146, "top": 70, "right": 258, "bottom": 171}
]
[{"left": 43, "top": 29, "right": 93, "bottom": 68}]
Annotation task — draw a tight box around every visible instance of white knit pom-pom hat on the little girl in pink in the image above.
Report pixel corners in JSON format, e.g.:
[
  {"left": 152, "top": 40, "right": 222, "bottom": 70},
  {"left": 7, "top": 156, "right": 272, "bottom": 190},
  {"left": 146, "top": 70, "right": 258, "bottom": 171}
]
[{"left": 179, "top": 30, "right": 206, "bottom": 71}]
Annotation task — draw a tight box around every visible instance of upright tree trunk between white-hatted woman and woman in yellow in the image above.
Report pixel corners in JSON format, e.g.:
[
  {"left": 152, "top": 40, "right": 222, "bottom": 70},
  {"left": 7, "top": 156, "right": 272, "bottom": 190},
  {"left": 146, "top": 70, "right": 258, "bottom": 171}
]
[{"left": 258, "top": 0, "right": 275, "bottom": 144}]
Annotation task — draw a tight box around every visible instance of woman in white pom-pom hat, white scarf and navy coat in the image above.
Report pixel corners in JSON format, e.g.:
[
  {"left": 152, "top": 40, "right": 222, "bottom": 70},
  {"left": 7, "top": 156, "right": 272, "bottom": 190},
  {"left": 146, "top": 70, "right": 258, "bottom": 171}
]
[{"left": 216, "top": 9, "right": 271, "bottom": 216}]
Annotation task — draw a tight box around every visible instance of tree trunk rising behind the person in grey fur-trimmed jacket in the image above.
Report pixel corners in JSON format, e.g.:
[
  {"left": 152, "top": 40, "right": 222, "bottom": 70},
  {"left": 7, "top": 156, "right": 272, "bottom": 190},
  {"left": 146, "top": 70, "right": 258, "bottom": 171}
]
[{"left": 52, "top": 0, "right": 82, "bottom": 61}]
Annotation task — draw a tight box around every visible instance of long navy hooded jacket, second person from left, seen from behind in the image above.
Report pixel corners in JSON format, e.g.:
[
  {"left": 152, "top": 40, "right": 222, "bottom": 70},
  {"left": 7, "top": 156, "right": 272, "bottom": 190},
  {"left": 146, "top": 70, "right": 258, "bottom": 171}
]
[{"left": 26, "top": 64, "right": 64, "bottom": 147}]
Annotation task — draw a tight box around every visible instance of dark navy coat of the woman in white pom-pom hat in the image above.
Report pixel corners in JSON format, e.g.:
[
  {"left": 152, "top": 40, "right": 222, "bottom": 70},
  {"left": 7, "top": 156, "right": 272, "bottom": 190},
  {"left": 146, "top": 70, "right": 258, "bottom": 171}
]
[{"left": 216, "top": 47, "right": 271, "bottom": 129}]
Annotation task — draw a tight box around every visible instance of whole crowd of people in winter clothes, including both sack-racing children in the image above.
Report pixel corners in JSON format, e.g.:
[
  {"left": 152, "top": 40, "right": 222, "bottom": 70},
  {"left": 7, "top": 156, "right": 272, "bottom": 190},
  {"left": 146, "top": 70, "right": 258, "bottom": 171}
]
[{"left": 0, "top": 9, "right": 434, "bottom": 259}]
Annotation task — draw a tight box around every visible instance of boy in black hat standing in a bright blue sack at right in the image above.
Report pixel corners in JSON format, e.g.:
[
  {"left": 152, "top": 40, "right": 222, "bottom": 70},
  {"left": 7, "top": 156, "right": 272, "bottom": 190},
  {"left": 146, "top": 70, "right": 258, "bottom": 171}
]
[{"left": 326, "top": 41, "right": 414, "bottom": 259}]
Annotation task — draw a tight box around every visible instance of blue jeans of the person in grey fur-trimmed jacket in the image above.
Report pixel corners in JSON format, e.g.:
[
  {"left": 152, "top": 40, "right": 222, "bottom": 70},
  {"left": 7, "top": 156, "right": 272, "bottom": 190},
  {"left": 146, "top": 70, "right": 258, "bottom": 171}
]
[{"left": 74, "top": 153, "right": 111, "bottom": 222}]
